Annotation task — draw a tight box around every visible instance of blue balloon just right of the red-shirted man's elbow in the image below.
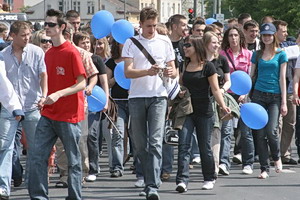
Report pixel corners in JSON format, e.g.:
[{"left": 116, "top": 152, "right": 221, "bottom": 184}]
[{"left": 87, "top": 85, "right": 107, "bottom": 112}]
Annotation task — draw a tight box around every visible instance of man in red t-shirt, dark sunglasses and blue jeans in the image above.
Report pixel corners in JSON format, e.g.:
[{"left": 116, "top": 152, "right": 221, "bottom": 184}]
[{"left": 28, "top": 9, "right": 86, "bottom": 200}]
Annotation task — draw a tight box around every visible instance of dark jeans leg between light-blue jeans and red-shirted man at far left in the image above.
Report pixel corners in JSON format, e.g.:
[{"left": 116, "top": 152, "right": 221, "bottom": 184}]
[{"left": 12, "top": 126, "right": 23, "bottom": 180}]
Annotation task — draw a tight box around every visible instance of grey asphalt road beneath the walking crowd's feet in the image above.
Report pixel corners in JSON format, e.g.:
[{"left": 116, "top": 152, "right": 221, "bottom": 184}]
[{"left": 10, "top": 144, "right": 300, "bottom": 200}]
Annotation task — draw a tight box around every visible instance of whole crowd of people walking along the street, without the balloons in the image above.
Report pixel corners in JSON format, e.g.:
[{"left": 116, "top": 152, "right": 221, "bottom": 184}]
[{"left": 0, "top": 7, "right": 300, "bottom": 200}]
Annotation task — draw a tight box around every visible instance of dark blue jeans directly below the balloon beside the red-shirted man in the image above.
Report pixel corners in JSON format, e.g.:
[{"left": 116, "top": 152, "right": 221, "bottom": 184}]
[{"left": 87, "top": 112, "right": 101, "bottom": 174}]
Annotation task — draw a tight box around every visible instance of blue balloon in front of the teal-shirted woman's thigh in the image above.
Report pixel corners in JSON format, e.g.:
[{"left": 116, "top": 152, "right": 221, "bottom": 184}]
[{"left": 241, "top": 103, "right": 269, "bottom": 130}]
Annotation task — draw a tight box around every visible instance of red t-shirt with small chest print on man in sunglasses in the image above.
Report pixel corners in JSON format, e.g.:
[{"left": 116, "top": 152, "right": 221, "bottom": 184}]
[{"left": 42, "top": 41, "right": 85, "bottom": 123}]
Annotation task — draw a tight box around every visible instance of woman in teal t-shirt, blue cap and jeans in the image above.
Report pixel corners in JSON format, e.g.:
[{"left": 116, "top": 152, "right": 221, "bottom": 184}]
[{"left": 251, "top": 23, "right": 288, "bottom": 179}]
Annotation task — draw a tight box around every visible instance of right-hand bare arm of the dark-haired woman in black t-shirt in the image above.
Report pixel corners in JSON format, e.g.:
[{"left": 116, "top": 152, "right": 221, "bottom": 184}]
[{"left": 208, "top": 73, "right": 231, "bottom": 113}]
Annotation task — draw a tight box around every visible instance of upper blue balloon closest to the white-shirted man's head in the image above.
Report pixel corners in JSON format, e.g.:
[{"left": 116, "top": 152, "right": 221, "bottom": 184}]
[{"left": 111, "top": 19, "right": 134, "bottom": 44}]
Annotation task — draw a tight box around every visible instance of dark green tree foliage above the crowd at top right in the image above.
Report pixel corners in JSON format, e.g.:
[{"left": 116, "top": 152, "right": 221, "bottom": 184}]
[{"left": 222, "top": 0, "right": 300, "bottom": 35}]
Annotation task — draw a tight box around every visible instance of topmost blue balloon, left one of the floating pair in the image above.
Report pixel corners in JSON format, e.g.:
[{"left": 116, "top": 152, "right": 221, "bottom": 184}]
[{"left": 91, "top": 10, "right": 115, "bottom": 39}]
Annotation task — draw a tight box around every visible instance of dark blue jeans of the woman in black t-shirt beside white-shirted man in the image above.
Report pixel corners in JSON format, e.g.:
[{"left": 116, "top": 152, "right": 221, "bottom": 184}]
[{"left": 176, "top": 114, "right": 216, "bottom": 185}]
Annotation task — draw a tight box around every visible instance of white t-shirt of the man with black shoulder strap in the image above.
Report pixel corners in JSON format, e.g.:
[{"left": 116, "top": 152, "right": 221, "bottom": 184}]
[{"left": 122, "top": 33, "right": 175, "bottom": 98}]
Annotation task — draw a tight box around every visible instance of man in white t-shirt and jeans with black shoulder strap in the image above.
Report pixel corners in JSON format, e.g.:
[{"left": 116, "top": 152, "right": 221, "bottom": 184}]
[{"left": 122, "top": 7, "right": 176, "bottom": 200}]
